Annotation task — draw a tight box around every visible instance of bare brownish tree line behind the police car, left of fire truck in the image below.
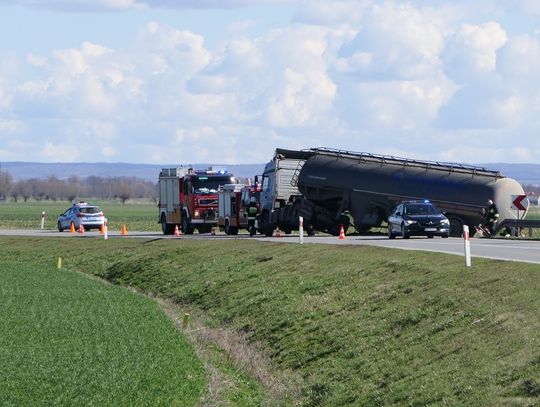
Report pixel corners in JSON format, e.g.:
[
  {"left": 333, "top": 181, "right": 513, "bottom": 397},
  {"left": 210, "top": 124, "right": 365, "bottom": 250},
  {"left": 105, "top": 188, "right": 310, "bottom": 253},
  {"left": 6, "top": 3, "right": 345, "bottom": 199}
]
[{"left": 0, "top": 171, "right": 158, "bottom": 203}]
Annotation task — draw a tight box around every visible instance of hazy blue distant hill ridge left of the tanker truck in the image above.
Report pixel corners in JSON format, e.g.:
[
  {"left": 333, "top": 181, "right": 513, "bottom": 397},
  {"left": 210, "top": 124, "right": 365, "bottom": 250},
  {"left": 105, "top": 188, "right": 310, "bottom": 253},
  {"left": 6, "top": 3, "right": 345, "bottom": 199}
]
[{"left": 0, "top": 162, "right": 264, "bottom": 182}]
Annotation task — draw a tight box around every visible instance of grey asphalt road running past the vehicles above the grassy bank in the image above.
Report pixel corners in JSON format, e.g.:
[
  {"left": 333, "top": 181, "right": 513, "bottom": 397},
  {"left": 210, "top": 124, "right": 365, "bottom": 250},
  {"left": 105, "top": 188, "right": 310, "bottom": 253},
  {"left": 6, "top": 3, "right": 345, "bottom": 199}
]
[{"left": 0, "top": 229, "right": 540, "bottom": 265}]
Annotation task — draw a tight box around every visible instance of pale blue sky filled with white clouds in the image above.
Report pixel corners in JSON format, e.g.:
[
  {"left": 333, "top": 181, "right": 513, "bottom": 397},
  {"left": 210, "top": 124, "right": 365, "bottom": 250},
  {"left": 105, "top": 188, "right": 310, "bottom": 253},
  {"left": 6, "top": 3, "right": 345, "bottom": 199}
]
[{"left": 0, "top": 0, "right": 540, "bottom": 164}]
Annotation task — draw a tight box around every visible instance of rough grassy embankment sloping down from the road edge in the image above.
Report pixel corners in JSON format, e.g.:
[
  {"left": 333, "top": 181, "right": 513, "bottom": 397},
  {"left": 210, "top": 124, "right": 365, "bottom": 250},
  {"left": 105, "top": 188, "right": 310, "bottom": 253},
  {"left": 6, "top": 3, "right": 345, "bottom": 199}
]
[{"left": 0, "top": 236, "right": 540, "bottom": 406}]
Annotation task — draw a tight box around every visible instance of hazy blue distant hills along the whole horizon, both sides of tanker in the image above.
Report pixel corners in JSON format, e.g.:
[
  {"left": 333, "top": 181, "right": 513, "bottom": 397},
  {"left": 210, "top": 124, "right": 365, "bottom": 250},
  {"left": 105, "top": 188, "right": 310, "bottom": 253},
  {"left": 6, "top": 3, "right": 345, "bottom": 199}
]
[{"left": 0, "top": 162, "right": 540, "bottom": 185}]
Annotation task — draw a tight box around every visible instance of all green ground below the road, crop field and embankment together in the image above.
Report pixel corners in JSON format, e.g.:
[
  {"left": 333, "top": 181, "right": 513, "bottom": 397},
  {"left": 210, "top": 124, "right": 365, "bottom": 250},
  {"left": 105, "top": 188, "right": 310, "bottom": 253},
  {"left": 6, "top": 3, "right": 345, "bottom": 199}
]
[{"left": 0, "top": 237, "right": 540, "bottom": 407}]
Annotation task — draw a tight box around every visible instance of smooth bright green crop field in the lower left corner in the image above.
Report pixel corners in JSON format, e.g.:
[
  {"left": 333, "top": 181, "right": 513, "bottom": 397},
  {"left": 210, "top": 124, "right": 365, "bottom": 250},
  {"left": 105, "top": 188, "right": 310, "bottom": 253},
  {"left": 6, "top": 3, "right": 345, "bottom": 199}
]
[{"left": 0, "top": 255, "right": 207, "bottom": 406}]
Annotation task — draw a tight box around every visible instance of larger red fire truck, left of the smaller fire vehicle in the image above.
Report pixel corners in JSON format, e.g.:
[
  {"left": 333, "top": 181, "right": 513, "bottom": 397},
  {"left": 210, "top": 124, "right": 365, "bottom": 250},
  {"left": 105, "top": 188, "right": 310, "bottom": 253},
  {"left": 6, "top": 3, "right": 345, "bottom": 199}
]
[{"left": 158, "top": 167, "right": 235, "bottom": 235}]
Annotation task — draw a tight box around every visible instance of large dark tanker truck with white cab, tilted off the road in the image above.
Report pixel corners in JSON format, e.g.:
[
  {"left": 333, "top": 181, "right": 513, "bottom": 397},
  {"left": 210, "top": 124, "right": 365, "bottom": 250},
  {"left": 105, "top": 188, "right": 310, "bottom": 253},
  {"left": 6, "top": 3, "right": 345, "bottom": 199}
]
[{"left": 260, "top": 148, "right": 524, "bottom": 236}]
